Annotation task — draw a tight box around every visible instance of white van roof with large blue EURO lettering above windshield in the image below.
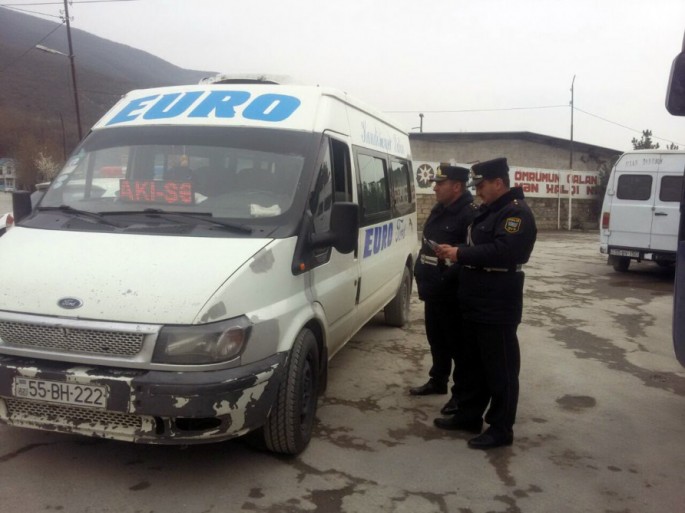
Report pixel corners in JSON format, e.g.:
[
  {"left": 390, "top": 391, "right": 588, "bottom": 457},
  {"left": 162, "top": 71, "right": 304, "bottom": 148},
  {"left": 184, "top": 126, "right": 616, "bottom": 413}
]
[{"left": 93, "top": 83, "right": 410, "bottom": 156}]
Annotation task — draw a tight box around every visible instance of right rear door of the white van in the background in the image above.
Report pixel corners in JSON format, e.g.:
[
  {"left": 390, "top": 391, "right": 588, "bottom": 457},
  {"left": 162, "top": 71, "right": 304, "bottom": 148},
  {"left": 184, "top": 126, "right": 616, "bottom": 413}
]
[{"left": 650, "top": 153, "right": 685, "bottom": 251}]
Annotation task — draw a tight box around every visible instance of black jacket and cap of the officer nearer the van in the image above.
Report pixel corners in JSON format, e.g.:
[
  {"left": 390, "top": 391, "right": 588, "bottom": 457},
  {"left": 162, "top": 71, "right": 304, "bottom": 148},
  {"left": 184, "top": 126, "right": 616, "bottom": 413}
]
[{"left": 414, "top": 166, "right": 478, "bottom": 301}]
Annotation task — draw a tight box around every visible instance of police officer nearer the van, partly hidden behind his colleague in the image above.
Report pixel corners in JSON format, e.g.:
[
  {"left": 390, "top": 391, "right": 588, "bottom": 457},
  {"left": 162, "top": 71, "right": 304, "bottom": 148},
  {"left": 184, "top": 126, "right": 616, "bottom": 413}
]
[{"left": 409, "top": 164, "right": 477, "bottom": 414}]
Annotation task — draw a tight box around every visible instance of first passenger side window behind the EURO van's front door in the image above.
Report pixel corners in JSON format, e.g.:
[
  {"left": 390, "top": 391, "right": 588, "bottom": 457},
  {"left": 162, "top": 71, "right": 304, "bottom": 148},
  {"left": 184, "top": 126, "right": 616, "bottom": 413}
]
[{"left": 357, "top": 151, "right": 391, "bottom": 225}]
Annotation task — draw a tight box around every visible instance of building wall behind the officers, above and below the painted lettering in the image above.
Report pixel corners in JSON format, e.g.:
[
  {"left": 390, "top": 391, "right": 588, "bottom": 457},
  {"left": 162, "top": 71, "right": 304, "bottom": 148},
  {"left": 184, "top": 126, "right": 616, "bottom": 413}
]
[{"left": 410, "top": 132, "right": 621, "bottom": 230}]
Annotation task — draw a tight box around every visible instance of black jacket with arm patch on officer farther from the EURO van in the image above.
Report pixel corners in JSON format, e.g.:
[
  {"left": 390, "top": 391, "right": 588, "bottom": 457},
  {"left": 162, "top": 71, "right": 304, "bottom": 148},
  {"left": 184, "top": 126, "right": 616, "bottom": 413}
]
[{"left": 457, "top": 164, "right": 537, "bottom": 324}]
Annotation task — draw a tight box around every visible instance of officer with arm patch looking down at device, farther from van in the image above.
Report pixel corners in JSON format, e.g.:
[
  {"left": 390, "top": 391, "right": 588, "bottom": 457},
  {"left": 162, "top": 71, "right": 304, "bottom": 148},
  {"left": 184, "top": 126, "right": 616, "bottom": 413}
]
[{"left": 434, "top": 158, "right": 537, "bottom": 449}]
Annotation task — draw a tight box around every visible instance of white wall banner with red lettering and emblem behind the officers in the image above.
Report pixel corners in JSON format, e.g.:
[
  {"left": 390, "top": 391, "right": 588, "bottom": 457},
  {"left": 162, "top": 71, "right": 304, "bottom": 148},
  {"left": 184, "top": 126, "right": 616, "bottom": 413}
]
[{"left": 414, "top": 161, "right": 600, "bottom": 199}]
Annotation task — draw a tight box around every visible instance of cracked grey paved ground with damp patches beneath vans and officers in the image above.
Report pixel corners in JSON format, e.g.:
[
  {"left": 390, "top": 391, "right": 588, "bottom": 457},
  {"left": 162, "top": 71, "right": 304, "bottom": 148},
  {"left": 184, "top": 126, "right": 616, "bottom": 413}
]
[{"left": 0, "top": 232, "right": 685, "bottom": 513}]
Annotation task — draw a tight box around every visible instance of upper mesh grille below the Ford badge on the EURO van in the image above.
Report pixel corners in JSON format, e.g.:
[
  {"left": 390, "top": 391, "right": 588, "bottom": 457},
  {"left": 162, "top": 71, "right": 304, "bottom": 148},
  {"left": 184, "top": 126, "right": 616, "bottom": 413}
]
[{"left": 0, "top": 321, "right": 145, "bottom": 356}]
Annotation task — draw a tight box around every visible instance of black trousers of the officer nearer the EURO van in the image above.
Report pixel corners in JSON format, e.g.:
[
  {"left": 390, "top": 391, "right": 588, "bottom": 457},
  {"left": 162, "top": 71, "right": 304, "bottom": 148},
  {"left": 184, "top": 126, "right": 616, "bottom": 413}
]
[{"left": 424, "top": 299, "right": 461, "bottom": 383}]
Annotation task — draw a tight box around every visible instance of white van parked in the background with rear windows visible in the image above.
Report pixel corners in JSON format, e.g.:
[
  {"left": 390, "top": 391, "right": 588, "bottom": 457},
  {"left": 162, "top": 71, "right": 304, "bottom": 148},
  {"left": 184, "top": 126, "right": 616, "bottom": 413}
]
[{"left": 600, "top": 150, "right": 685, "bottom": 272}]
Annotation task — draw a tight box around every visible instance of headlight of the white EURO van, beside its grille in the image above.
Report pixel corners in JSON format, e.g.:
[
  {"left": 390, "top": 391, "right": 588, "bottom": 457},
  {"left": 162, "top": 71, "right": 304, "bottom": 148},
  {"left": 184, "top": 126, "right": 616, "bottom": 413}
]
[{"left": 152, "top": 316, "right": 252, "bottom": 365}]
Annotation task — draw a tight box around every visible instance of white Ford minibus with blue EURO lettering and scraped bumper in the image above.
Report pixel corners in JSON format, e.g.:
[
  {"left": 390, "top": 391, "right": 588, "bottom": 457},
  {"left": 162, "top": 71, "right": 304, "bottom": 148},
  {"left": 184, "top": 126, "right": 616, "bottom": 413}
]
[{"left": 0, "top": 81, "right": 417, "bottom": 454}]
